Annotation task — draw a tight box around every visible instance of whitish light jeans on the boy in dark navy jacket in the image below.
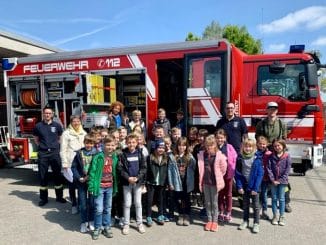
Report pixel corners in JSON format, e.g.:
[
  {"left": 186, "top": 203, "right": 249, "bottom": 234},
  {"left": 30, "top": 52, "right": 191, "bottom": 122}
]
[{"left": 123, "top": 184, "right": 143, "bottom": 225}]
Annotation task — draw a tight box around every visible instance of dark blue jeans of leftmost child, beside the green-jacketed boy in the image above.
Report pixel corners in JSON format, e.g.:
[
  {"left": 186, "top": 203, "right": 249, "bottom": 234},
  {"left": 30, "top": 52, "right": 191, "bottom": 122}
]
[{"left": 78, "top": 184, "right": 94, "bottom": 223}]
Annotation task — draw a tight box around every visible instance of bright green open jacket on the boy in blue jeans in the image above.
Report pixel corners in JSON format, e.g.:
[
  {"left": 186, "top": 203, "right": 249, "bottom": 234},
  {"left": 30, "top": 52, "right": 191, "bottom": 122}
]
[{"left": 88, "top": 152, "right": 118, "bottom": 197}]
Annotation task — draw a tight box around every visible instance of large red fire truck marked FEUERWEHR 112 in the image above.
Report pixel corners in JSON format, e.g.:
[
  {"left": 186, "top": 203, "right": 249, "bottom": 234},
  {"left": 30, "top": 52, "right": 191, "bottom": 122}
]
[{"left": 2, "top": 39, "right": 324, "bottom": 172}]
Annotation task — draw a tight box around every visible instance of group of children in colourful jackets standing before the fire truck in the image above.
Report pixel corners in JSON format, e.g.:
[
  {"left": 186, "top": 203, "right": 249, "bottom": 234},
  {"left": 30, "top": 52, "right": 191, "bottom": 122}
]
[{"left": 67, "top": 106, "right": 291, "bottom": 240}]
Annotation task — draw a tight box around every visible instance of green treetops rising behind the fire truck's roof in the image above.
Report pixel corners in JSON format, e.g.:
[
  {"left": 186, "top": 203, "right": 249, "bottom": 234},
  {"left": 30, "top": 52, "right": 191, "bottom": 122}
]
[{"left": 186, "top": 21, "right": 262, "bottom": 54}]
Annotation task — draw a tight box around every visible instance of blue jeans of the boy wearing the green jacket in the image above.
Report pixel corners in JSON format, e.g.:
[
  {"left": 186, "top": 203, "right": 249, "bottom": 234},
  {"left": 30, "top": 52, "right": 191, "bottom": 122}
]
[{"left": 94, "top": 187, "right": 112, "bottom": 230}]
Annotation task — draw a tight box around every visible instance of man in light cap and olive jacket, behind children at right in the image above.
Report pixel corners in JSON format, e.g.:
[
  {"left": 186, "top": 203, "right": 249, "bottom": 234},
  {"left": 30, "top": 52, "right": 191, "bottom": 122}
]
[{"left": 255, "top": 101, "right": 292, "bottom": 213}]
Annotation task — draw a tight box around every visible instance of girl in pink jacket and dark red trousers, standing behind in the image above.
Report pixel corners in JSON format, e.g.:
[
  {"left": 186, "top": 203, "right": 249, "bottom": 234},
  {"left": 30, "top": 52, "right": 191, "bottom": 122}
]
[{"left": 215, "top": 129, "right": 238, "bottom": 222}]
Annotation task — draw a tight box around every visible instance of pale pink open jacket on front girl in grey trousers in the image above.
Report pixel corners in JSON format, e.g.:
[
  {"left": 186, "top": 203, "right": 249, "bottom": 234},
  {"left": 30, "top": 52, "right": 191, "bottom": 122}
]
[{"left": 197, "top": 151, "right": 227, "bottom": 192}]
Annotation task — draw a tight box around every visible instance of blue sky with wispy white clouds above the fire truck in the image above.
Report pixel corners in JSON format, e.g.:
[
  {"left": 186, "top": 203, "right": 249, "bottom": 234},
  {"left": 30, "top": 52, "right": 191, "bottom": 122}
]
[{"left": 0, "top": 0, "right": 326, "bottom": 63}]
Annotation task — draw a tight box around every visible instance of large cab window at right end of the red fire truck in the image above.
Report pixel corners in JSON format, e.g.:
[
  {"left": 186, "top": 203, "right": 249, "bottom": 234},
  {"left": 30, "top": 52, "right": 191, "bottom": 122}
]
[{"left": 257, "top": 64, "right": 309, "bottom": 101}]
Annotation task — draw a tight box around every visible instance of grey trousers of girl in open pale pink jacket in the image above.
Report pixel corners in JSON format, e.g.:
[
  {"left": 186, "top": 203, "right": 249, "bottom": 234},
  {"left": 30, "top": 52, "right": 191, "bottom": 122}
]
[{"left": 203, "top": 185, "right": 218, "bottom": 222}]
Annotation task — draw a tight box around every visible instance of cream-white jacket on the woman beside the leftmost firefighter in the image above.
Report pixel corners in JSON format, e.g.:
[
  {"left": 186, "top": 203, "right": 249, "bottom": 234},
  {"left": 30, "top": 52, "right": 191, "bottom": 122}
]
[{"left": 60, "top": 125, "right": 87, "bottom": 168}]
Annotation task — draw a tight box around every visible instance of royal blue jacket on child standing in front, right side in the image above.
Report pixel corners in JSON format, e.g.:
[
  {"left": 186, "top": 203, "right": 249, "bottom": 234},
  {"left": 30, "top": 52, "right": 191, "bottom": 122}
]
[{"left": 235, "top": 151, "right": 264, "bottom": 192}]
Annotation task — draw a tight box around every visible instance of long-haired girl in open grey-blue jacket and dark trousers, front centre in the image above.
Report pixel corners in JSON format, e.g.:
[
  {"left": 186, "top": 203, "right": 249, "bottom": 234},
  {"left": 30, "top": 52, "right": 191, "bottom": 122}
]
[{"left": 169, "top": 137, "right": 196, "bottom": 226}]
